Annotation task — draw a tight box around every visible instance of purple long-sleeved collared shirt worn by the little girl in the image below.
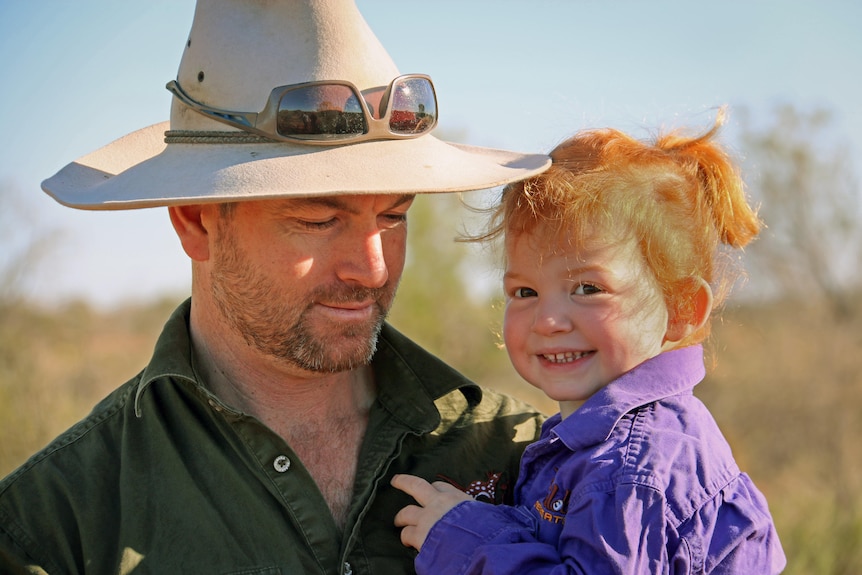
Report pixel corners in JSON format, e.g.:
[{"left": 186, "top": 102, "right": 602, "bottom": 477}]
[{"left": 416, "top": 346, "right": 786, "bottom": 575}]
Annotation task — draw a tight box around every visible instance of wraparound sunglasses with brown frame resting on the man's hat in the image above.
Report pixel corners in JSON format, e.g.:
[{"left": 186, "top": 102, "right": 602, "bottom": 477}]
[{"left": 165, "top": 74, "right": 437, "bottom": 146}]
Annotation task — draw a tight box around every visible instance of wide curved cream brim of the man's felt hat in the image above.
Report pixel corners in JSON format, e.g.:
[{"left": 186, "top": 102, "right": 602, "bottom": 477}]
[{"left": 42, "top": 122, "right": 550, "bottom": 210}]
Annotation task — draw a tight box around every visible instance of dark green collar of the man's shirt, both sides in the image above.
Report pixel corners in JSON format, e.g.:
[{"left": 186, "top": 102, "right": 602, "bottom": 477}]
[{"left": 135, "top": 299, "right": 482, "bottom": 432}]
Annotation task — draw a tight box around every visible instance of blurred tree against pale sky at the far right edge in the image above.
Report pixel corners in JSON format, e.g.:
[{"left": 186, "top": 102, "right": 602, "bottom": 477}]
[{"left": 741, "top": 105, "right": 862, "bottom": 319}]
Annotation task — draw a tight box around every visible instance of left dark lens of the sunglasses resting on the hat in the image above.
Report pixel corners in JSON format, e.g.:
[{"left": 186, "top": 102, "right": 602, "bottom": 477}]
[{"left": 277, "top": 84, "right": 368, "bottom": 140}]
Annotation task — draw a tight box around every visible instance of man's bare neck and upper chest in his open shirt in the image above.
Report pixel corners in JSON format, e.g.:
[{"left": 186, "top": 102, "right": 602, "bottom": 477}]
[{"left": 192, "top": 306, "right": 376, "bottom": 528}]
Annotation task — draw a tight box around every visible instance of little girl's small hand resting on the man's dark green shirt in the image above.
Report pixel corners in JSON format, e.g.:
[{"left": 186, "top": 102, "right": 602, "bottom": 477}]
[{"left": 392, "top": 475, "right": 472, "bottom": 551}]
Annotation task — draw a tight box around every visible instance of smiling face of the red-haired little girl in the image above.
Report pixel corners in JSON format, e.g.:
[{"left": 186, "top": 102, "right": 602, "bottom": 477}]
[{"left": 503, "top": 228, "right": 668, "bottom": 417}]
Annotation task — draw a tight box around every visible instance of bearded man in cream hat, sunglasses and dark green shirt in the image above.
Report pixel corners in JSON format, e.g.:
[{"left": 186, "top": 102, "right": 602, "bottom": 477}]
[{"left": 0, "top": 0, "right": 548, "bottom": 575}]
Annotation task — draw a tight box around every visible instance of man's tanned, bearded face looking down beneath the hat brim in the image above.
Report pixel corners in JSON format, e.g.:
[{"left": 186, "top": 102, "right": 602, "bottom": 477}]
[{"left": 211, "top": 195, "right": 412, "bottom": 373}]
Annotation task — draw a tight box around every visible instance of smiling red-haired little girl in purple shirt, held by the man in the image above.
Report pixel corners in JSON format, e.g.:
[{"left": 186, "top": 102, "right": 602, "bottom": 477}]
[{"left": 392, "top": 114, "right": 785, "bottom": 575}]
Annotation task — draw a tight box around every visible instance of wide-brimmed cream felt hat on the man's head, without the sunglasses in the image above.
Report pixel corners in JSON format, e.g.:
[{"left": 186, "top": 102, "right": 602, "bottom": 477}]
[{"left": 42, "top": 0, "right": 550, "bottom": 210}]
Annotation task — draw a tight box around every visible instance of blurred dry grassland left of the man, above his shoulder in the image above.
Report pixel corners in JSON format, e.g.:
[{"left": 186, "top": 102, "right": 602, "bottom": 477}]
[{"left": 0, "top": 299, "right": 179, "bottom": 476}]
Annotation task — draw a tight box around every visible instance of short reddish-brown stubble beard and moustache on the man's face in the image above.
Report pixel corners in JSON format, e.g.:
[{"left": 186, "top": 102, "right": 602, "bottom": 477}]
[{"left": 211, "top": 232, "right": 395, "bottom": 373}]
